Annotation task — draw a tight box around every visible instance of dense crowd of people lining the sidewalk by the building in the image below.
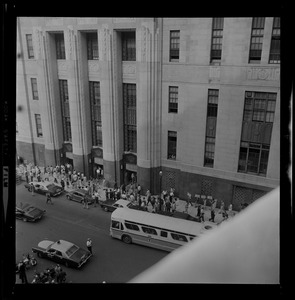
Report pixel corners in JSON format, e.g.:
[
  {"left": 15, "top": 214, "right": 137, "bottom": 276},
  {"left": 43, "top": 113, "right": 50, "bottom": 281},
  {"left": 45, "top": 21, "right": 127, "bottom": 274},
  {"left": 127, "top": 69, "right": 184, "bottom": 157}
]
[{"left": 16, "top": 164, "right": 238, "bottom": 222}]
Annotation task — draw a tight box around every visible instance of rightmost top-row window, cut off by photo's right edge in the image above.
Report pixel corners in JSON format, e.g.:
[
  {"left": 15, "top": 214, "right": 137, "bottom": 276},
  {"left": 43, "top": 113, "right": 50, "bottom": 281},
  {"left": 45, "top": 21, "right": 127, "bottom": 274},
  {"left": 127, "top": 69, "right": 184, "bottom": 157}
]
[{"left": 269, "top": 17, "right": 281, "bottom": 64}]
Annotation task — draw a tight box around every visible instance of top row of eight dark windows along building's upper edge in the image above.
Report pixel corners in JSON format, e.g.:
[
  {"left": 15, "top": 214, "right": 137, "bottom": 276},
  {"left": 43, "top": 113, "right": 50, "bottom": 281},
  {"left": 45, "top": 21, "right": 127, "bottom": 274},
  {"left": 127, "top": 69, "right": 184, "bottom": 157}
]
[{"left": 26, "top": 17, "right": 281, "bottom": 64}]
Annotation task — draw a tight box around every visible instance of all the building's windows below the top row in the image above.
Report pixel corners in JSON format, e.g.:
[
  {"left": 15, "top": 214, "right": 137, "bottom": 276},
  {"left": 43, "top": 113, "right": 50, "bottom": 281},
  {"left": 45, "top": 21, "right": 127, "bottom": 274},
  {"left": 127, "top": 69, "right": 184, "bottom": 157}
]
[{"left": 25, "top": 78, "right": 276, "bottom": 175}]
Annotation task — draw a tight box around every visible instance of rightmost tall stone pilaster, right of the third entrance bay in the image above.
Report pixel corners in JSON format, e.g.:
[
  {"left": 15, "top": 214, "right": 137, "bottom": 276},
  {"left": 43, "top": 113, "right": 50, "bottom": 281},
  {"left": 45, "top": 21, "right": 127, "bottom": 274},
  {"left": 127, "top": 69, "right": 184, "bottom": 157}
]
[{"left": 137, "top": 19, "right": 162, "bottom": 192}]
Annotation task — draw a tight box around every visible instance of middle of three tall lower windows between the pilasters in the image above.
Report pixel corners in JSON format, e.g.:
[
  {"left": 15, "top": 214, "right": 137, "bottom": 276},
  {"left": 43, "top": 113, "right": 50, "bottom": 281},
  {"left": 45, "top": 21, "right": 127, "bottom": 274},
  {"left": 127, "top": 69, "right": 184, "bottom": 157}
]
[{"left": 89, "top": 81, "right": 102, "bottom": 147}]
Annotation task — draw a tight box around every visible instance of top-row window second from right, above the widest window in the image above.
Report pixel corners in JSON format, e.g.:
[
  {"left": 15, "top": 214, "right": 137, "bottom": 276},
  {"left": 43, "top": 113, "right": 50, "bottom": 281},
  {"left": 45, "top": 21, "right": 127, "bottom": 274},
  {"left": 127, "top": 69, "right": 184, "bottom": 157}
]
[{"left": 249, "top": 18, "right": 265, "bottom": 63}]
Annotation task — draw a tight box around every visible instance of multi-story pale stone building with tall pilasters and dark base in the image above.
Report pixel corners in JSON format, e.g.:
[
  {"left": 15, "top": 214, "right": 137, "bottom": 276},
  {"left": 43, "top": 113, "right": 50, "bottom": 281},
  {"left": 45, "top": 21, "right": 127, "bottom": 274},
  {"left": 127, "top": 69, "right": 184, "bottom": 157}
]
[{"left": 16, "top": 17, "right": 280, "bottom": 207}]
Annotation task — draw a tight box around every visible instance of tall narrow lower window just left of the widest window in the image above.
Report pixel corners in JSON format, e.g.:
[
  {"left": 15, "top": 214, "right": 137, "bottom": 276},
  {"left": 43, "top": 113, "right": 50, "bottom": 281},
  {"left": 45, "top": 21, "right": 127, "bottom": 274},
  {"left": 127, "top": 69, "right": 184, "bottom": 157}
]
[{"left": 204, "top": 89, "right": 219, "bottom": 168}]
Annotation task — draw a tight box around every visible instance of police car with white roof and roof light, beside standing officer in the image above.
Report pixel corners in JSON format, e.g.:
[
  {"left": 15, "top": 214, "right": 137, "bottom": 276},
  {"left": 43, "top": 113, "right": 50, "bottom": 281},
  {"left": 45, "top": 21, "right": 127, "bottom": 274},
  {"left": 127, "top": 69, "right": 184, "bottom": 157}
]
[{"left": 32, "top": 240, "right": 92, "bottom": 268}]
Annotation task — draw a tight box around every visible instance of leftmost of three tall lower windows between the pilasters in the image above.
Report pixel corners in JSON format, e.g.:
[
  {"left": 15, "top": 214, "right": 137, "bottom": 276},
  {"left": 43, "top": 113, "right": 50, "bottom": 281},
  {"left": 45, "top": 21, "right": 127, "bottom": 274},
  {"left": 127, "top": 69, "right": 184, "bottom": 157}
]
[{"left": 59, "top": 79, "right": 72, "bottom": 142}]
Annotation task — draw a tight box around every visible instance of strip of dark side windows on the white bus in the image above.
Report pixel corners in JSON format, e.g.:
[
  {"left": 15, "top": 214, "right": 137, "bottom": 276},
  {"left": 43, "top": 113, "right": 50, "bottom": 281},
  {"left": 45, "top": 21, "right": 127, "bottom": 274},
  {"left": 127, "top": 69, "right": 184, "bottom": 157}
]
[{"left": 112, "top": 220, "right": 195, "bottom": 242}]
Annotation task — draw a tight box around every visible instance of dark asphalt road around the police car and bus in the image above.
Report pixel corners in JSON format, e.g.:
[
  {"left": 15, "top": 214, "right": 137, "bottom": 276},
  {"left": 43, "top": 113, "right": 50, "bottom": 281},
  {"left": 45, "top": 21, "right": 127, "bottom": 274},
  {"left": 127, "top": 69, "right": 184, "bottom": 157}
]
[{"left": 16, "top": 184, "right": 168, "bottom": 283}]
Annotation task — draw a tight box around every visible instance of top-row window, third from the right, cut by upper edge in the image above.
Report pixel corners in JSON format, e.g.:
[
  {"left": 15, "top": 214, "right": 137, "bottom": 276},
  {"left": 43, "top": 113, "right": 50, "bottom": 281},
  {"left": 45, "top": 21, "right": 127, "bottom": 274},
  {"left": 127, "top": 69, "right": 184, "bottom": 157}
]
[{"left": 210, "top": 18, "right": 224, "bottom": 62}]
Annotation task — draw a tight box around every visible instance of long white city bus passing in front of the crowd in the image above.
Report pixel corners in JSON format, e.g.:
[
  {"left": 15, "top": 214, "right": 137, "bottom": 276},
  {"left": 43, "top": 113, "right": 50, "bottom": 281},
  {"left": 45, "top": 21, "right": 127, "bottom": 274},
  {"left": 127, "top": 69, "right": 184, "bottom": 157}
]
[{"left": 110, "top": 208, "right": 216, "bottom": 251}]
